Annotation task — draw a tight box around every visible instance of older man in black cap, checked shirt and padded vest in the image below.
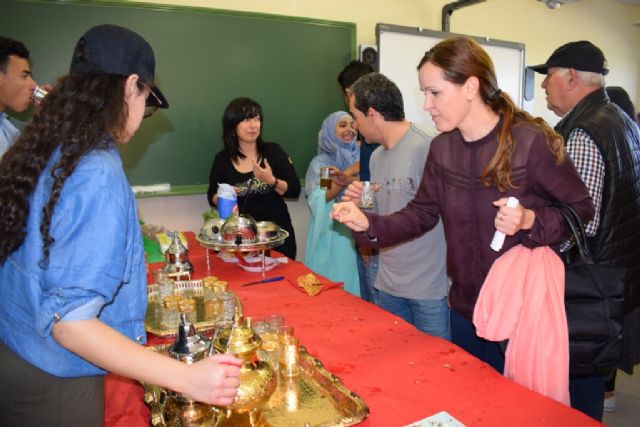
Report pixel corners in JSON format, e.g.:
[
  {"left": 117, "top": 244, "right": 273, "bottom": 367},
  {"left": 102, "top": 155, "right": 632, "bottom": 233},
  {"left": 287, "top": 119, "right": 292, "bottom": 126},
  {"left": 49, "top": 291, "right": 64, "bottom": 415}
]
[{"left": 531, "top": 41, "right": 640, "bottom": 420}]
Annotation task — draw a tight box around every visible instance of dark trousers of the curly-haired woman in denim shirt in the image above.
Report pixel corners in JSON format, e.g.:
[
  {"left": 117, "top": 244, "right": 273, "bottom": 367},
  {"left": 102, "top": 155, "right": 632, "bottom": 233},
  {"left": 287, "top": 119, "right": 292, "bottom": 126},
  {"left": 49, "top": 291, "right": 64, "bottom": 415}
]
[{"left": 0, "top": 343, "right": 104, "bottom": 427}]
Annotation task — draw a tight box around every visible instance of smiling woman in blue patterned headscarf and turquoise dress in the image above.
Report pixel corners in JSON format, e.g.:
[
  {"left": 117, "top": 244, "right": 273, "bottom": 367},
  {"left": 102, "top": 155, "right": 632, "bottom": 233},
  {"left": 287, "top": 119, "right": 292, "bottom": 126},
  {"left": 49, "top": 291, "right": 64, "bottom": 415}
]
[{"left": 304, "top": 111, "right": 360, "bottom": 296}]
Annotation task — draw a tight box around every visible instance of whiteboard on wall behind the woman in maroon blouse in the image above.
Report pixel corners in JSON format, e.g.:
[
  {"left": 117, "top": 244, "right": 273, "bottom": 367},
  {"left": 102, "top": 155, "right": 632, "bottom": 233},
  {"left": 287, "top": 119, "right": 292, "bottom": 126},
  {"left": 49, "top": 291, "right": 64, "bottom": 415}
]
[{"left": 376, "top": 24, "right": 525, "bottom": 135}]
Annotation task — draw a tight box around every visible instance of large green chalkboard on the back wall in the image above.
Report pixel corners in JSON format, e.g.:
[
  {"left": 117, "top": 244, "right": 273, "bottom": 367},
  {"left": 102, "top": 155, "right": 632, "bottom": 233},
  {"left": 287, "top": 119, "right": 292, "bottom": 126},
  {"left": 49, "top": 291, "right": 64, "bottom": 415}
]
[{"left": 0, "top": 0, "right": 355, "bottom": 193}]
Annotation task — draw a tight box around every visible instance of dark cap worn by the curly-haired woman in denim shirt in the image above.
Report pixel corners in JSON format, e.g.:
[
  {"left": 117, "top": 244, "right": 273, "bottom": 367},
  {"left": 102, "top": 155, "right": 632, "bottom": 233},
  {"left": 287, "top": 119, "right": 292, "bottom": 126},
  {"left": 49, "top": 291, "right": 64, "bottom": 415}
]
[{"left": 69, "top": 25, "right": 169, "bottom": 108}]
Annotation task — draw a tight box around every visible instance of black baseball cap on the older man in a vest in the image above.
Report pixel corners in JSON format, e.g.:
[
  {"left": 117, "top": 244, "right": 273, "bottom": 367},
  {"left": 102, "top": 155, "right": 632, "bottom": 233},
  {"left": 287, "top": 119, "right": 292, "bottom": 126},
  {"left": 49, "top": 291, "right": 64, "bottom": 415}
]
[{"left": 529, "top": 40, "right": 609, "bottom": 76}]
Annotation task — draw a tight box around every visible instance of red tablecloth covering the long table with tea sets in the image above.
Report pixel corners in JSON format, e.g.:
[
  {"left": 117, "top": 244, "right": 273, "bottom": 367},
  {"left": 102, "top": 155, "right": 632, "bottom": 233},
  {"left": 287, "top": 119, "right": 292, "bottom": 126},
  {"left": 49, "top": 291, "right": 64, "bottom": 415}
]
[{"left": 105, "top": 235, "right": 601, "bottom": 427}]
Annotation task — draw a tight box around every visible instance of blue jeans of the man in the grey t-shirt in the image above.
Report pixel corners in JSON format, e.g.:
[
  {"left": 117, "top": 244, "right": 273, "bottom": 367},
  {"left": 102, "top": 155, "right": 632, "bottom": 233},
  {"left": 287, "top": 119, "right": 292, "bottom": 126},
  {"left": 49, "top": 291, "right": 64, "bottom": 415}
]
[{"left": 378, "top": 291, "right": 451, "bottom": 340}]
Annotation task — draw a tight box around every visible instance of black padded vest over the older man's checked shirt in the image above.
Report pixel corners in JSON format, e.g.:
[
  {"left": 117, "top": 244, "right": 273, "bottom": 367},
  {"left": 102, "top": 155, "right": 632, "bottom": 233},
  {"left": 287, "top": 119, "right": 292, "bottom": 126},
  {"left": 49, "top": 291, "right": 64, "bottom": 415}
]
[{"left": 556, "top": 89, "right": 640, "bottom": 313}]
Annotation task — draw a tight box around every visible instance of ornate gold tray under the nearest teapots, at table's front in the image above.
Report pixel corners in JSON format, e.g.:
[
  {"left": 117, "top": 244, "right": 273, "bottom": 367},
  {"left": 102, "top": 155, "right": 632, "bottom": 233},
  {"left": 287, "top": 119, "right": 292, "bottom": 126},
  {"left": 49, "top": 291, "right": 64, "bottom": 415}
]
[{"left": 142, "top": 345, "right": 369, "bottom": 427}]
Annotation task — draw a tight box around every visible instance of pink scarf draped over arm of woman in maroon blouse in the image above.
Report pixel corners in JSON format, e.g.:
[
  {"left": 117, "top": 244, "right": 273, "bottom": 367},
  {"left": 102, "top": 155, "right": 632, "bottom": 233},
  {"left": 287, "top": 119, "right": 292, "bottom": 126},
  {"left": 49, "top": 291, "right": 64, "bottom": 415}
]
[{"left": 473, "top": 245, "right": 569, "bottom": 405}]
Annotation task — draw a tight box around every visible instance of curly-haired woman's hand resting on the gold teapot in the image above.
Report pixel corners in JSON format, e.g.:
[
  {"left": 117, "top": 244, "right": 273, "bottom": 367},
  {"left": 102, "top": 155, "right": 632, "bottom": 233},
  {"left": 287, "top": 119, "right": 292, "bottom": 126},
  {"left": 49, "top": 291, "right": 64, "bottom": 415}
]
[{"left": 184, "top": 354, "right": 241, "bottom": 405}]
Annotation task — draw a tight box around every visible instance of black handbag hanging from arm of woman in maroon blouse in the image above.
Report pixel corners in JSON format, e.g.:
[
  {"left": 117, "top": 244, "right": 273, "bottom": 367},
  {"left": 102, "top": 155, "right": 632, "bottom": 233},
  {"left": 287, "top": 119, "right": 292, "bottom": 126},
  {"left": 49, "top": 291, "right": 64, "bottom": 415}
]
[{"left": 558, "top": 205, "right": 626, "bottom": 374}]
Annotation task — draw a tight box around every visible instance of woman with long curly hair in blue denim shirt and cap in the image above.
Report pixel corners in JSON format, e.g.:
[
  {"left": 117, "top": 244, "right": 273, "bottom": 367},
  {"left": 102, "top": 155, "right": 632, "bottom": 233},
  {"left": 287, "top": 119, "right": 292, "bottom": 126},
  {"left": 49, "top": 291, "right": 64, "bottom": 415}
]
[{"left": 0, "top": 25, "right": 239, "bottom": 426}]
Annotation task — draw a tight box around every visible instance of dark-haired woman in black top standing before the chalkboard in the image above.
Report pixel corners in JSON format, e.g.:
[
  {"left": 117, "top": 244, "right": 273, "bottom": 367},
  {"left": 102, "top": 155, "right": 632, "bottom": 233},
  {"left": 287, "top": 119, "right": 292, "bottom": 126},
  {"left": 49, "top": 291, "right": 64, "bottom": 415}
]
[{"left": 207, "top": 98, "right": 300, "bottom": 259}]
